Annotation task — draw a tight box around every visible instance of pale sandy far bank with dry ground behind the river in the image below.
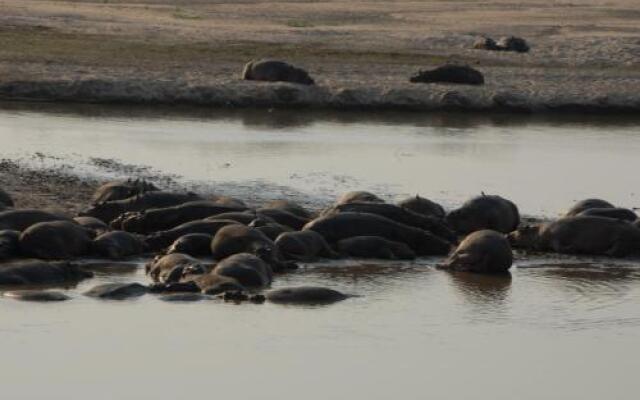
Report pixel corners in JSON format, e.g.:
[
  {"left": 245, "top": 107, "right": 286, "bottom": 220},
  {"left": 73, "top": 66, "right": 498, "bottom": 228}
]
[{"left": 0, "top": 0, "right": 640, "bottom": 110}]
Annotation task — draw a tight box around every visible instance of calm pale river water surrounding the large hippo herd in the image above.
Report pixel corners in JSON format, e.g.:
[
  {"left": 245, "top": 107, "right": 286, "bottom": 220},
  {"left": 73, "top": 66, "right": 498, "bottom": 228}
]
[{"left": 0, "top": 108, "right": 640, "bottom": 400}]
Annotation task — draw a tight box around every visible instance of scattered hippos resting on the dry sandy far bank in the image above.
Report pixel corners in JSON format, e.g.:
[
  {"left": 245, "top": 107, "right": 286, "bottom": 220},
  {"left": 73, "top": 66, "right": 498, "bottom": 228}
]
[{"left": 242, "top": 36, "right": 529, "bottom": 85}]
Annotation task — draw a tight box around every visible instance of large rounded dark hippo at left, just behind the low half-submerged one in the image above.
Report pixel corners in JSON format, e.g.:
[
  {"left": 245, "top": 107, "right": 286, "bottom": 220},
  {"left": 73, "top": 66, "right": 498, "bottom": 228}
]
[{"left": 20, "top": 221, "right": 92, "bottom": 260}]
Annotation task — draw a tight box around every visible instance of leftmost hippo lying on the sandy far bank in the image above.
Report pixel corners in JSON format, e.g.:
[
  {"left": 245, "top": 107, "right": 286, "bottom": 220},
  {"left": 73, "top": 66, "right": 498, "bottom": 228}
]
[{"left": 242, "top": 60, "right": 315, "bottom": 85}]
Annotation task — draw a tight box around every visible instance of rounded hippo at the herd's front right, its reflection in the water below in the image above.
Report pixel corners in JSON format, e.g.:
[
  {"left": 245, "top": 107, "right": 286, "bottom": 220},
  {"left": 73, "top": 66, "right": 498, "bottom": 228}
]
[{"left": 439, "top": 229, "right": 513, "bottom": 274}]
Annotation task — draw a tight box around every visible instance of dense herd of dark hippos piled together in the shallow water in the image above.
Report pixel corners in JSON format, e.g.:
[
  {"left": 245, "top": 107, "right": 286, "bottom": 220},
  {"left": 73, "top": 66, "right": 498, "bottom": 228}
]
[{"left": 0, "top": 180, "right": 640, "bottom": 304}]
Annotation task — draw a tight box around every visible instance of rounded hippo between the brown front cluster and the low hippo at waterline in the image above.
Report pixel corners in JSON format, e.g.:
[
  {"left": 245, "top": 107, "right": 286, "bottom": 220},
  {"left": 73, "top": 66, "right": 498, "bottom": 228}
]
[{"left": 275, "top": 230, "right": 338, "bottom": 261}]
